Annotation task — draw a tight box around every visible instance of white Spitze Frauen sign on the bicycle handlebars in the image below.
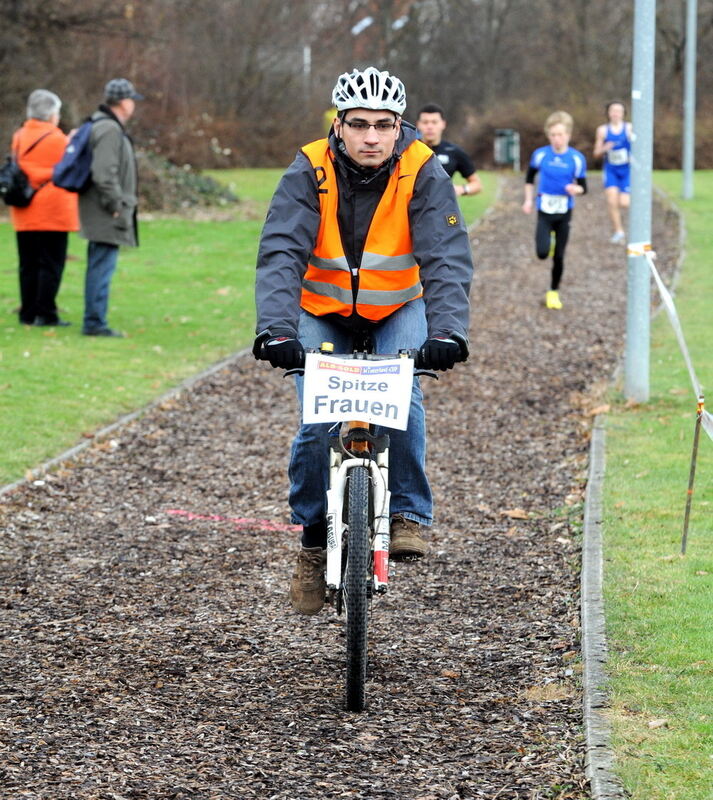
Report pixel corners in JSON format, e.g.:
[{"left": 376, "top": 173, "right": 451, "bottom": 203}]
[{"left": 302, "top": 353, "right": 413, "bottom": 431}]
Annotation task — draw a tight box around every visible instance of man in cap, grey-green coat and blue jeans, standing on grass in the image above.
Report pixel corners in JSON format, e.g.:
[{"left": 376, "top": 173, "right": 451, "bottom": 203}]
[{"left": 79, "top": 78, "right": 143, "bottom": 336}]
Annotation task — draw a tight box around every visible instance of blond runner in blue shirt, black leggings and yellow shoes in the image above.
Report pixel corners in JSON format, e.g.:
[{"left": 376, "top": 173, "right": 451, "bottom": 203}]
[{"left": 522, "top": 111, "right": 587, "bottom": 309}]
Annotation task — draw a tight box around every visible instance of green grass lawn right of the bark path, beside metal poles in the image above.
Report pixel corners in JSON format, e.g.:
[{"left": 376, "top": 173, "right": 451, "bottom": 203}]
[{"left": 604, "top": 172, "right": 713, "bottom": 800}]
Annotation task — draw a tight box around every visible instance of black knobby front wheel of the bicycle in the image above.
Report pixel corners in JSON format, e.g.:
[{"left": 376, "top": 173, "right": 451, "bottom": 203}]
[{"left": 344, "top": 467, "right": 370, "bottom": 711}]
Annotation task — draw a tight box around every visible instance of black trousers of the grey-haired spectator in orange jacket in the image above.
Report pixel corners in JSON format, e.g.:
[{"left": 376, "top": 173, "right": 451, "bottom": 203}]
[{"left": 16, "top": 231, "right": 68, "bottom": 325}]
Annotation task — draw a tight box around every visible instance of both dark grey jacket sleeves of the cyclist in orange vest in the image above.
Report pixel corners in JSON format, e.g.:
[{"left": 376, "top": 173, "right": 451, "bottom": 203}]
[{"left": 255, "top": 125, "right": 473, "bottom": 343}]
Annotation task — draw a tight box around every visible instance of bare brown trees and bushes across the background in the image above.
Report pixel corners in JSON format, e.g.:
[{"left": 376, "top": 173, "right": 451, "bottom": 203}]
[{"left": 0, "top": 0, "right": 713, "bottom": 165}]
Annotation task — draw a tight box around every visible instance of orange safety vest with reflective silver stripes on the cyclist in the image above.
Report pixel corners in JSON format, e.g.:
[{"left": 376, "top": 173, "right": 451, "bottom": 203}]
[{"left": 301, "top": 139, "right": 433, "bottom": 322}]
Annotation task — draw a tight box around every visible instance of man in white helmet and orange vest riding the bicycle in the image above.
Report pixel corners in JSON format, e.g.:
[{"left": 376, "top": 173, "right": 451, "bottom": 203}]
[{"left": 253, "top": 67, "right": 473, "bottom": 614}]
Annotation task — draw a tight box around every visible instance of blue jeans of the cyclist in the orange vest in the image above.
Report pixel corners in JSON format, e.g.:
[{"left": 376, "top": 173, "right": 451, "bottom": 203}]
[{"left": 288, "top": 298, "right": 433, "bottom": 525}]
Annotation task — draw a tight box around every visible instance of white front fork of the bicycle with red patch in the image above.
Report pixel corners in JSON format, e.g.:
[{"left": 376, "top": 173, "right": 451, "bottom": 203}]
[{"left": 327, "top": 448, "right": 391, "bottom": 594}]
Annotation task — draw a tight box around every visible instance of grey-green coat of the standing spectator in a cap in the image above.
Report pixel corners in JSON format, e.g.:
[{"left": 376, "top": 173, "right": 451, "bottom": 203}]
[{"left": 79, "top": 106, "right": 138, "bottom": 247}]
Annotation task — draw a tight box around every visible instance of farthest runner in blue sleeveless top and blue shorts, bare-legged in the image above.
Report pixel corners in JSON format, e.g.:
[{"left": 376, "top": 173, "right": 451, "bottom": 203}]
[{"left": 594, "top": 100, "right": 631, "bottom": 244}]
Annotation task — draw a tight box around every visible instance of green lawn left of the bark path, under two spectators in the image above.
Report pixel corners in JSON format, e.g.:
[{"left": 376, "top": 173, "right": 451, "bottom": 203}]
[{"left": 0, "top": 169, "right": 497, "bottom": 485}]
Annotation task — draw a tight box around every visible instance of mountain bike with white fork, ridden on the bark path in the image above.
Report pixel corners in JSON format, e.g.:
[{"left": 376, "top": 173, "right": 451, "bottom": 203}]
[{"left": 298, "top": 343, "right": 436, "bottom": 711}]
